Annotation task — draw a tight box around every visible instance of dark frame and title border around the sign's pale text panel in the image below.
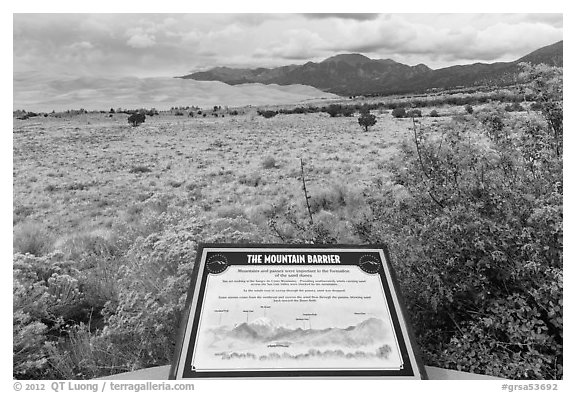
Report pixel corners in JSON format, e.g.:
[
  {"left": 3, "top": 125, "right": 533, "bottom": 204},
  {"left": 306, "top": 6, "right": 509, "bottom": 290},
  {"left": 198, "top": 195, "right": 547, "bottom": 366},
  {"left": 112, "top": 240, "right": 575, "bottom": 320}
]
[{"left": 169, "top": 243, "right": 427, "bottom": 379}]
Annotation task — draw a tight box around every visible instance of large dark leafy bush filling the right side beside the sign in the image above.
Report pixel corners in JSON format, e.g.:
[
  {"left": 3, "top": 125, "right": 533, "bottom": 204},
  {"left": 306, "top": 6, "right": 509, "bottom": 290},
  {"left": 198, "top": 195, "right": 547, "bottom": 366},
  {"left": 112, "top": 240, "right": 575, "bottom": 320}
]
[{"left": 357, "top": 65, "right": 563, "bottom": 379}]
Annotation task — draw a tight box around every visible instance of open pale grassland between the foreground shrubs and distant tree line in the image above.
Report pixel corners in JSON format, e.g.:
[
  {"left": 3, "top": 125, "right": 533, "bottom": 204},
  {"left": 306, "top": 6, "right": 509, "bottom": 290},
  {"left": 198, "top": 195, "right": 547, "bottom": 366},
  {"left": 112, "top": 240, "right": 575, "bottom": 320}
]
[{"left": 13, "top": 105, "right": 454, "bottom": 239}]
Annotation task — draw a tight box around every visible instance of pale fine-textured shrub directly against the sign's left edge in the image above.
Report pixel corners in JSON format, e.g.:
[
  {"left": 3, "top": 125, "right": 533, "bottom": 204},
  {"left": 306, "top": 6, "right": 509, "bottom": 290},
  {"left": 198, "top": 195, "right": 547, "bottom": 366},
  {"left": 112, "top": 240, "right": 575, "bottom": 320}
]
[{"left": 102, "top": 224, "right": 199, "bottom": 368}]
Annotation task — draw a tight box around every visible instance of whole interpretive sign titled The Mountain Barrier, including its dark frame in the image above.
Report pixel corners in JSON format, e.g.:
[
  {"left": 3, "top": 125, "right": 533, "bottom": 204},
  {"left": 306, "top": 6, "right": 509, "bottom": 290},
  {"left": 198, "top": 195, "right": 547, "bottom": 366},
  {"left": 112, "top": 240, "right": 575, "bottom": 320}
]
[{"left": 170, "top": 244, "right": 426, "bottom": 379}]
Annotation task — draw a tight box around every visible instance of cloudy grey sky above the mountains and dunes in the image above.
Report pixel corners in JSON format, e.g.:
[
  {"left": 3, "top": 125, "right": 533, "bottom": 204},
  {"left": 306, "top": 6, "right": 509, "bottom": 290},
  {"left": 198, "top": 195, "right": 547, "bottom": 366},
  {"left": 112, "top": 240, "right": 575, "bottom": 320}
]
[{"left": 13, "top": 14, "right": 563, "bottom": 77}]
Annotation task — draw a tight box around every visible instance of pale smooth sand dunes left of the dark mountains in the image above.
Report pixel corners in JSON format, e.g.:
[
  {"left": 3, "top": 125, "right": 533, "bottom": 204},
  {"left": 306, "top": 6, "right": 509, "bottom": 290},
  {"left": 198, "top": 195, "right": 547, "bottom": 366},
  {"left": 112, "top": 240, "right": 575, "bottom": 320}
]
[{"left": 14, "top": 72, "right": 337, "bottom": 111}]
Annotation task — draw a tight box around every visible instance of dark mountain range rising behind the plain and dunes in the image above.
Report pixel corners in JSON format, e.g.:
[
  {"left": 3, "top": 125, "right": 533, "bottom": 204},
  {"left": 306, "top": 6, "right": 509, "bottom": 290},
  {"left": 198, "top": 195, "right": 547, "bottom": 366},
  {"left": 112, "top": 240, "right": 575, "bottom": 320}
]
[{"left": 179, "top": 41, "right": 563, "bottom": 96}]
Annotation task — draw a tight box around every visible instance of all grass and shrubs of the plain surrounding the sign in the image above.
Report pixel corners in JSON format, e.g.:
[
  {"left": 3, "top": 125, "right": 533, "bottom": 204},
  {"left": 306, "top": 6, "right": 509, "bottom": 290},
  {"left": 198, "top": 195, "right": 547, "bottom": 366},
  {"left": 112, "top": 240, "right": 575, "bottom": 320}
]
[{"left": 13, "top": 66, "right": 563, "bottom": 379}]
